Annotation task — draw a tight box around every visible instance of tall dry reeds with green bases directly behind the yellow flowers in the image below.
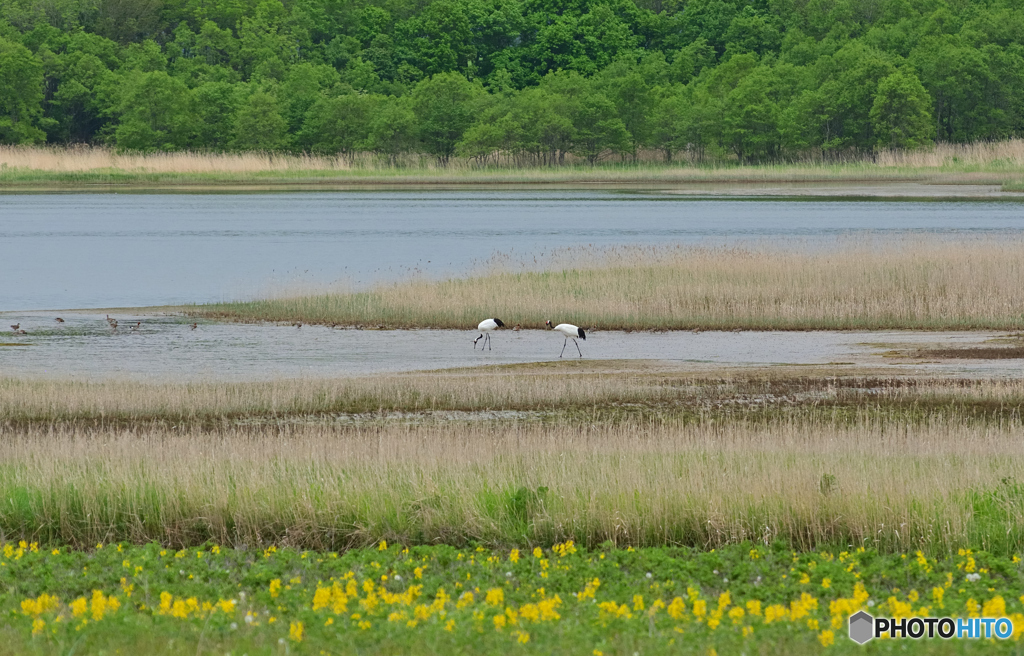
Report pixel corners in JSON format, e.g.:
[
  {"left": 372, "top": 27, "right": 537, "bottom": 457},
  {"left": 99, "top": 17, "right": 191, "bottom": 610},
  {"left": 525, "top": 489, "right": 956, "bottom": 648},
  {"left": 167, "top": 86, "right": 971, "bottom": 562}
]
[{"left": 0, "top": 413, "right": 1024, "bottom": 553}]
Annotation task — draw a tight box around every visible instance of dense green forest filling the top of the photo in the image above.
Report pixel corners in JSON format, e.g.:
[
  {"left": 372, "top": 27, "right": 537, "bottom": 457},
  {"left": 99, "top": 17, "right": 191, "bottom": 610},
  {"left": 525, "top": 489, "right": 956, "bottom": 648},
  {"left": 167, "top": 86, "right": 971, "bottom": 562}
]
[{"left": 0, "top": 0, "right": 1024, "bottom": 164}]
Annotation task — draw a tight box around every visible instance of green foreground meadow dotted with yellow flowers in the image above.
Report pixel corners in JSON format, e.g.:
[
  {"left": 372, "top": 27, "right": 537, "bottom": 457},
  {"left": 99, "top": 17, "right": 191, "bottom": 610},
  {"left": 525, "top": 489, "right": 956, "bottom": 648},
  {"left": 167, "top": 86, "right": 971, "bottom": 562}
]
[{"left": 0, "top": 542, "right": 1024, "bottom": 656}]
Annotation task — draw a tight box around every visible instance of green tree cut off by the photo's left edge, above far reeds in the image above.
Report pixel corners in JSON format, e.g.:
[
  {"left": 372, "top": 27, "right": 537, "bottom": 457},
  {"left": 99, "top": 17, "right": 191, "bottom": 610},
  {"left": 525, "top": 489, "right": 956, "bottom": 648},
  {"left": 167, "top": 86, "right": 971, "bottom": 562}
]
[{"left": 0, "top": 38, "right": 46, "bottom": 143}]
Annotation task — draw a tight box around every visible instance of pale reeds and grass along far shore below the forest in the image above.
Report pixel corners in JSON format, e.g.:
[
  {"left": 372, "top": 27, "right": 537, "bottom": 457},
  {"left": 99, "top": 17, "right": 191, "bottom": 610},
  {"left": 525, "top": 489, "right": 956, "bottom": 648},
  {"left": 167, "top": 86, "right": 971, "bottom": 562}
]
[{"left": 6, "top": 139, "right": 1024, "bottom": 189}]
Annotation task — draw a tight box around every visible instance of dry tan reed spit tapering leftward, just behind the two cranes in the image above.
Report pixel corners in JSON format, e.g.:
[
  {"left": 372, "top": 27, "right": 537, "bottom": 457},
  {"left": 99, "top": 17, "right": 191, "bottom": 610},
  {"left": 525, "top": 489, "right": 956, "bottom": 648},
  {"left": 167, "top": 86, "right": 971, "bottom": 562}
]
[{"left": 192, "top": 237, "right": 1024, "bottom": 331}]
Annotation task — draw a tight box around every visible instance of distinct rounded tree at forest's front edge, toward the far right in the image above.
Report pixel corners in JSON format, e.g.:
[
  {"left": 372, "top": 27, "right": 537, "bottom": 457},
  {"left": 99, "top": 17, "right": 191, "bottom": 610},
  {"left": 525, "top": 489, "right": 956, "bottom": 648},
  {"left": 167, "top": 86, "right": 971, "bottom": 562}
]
[{"left": 871, "top": 72, "right": 934, "bottom": 148}]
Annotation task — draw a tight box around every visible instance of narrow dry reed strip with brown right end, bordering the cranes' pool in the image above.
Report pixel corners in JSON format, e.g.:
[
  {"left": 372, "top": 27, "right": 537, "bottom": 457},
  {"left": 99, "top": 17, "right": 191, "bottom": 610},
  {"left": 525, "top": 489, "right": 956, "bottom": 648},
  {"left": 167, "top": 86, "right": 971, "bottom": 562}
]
[{"left": 6, "top": 362, "right": 1024, "bottom": 431}]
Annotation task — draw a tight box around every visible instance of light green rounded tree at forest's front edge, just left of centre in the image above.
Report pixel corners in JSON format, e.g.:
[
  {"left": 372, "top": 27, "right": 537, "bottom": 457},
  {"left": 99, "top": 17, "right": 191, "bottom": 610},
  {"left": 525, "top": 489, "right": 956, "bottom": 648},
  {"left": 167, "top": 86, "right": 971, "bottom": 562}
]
[{"left": 412, "top": 73, "right": 487, "bottom": 166}]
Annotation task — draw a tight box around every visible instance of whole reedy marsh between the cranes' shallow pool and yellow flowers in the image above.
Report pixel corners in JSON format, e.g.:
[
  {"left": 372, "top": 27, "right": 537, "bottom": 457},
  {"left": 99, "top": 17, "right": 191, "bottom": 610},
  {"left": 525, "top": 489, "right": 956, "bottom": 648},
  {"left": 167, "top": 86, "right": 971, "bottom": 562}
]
[{"left": 0, "top": 371, "right": 1024, "bottom": 554}]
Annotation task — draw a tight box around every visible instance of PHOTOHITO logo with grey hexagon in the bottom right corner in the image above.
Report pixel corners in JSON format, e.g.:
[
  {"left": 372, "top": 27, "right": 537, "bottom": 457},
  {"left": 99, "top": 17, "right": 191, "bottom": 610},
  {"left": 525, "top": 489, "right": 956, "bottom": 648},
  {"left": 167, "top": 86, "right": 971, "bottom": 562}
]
[{"left": 850, "top": 611, "right": 1014, "bottom": 645}]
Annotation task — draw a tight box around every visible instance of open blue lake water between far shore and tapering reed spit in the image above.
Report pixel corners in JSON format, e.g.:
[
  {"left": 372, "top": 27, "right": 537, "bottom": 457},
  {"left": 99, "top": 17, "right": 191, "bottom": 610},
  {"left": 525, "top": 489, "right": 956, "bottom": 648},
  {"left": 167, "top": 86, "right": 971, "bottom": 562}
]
[{"left": 0, "top": 190, "right": 1024, "bottom": 311}]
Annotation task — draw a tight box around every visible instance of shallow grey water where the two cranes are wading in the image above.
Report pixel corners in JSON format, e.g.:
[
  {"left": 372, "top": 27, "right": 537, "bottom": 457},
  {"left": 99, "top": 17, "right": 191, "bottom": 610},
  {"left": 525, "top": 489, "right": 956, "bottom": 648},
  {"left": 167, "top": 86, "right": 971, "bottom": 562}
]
[{"left": 0, "top": 312, "right": 1021, "bottom": 382}]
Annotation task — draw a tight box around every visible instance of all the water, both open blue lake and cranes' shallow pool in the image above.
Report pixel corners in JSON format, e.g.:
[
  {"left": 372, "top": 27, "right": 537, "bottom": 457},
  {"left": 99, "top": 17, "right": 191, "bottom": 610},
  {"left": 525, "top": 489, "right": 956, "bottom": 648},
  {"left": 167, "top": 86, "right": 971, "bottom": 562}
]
[{"left": 0, "top": 189, "right": 1024, "bottom": 380}]
